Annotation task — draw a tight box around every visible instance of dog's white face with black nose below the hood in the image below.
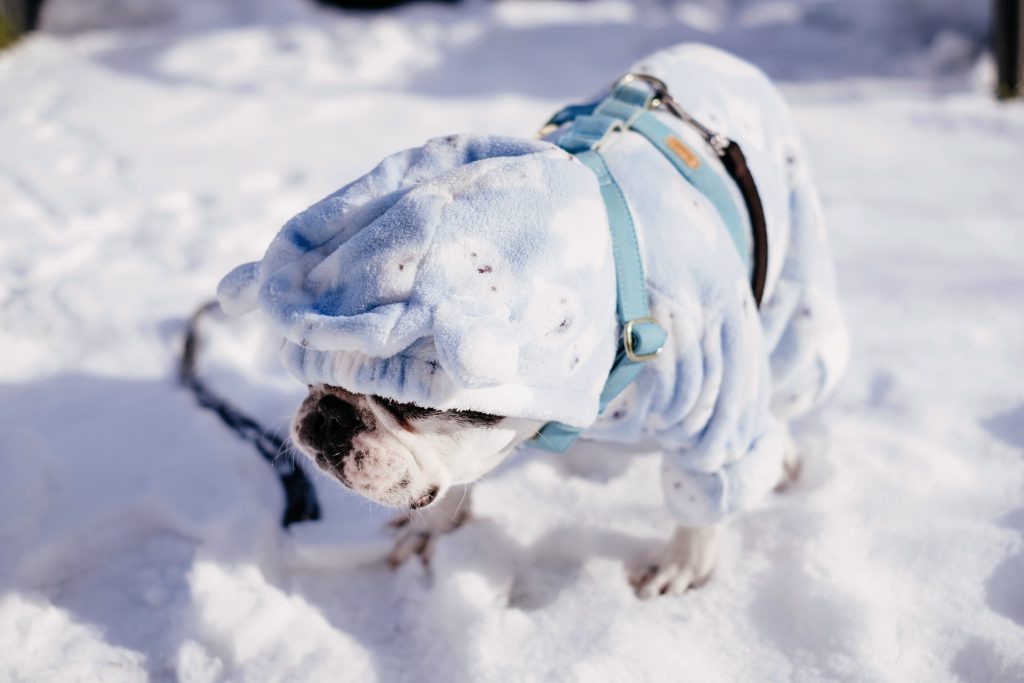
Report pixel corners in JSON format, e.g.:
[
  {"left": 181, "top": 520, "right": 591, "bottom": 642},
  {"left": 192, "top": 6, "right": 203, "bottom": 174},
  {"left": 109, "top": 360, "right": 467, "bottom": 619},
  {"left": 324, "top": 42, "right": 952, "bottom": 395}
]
[{"left": 292, "top": 384, "right": 544, "bottom": 509}]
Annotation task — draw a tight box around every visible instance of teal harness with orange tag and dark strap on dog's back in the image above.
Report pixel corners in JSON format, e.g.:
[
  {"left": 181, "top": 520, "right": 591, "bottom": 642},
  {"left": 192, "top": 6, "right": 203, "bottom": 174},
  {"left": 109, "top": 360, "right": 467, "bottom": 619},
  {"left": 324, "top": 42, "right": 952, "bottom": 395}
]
[{"left": 531, "top": 74, "right": 768, "bottom": 453}]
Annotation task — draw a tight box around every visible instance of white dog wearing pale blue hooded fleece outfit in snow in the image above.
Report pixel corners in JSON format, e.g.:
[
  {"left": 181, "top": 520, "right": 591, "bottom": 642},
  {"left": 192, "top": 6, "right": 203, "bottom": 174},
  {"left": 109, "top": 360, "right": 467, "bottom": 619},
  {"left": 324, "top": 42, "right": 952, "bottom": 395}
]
[{"left": 218, "top": 45, "right": 848, "bottom": 598}]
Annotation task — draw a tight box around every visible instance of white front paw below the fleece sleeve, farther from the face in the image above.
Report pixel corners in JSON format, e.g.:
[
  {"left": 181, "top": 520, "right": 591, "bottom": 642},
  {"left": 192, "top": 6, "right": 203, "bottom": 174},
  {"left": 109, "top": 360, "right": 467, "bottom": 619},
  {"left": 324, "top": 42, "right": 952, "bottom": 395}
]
[{"left": 630, "top": 526, "right": 718, "bottom": 600}]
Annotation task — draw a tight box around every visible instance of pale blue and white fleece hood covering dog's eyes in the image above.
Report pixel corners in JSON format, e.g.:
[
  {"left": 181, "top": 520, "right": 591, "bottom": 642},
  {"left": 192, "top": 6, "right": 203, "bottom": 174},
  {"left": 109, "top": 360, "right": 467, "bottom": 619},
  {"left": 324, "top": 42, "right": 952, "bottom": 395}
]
[{"left": 217, "top": 135, "right": 615, "bottom": 427}]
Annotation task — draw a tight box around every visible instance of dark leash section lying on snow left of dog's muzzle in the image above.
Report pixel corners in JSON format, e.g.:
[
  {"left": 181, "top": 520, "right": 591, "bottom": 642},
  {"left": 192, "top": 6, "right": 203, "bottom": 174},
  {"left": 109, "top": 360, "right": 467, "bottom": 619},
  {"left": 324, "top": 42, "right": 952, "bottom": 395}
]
[{"left": 178, "top": 301, "right": 321, "bottom": 528}]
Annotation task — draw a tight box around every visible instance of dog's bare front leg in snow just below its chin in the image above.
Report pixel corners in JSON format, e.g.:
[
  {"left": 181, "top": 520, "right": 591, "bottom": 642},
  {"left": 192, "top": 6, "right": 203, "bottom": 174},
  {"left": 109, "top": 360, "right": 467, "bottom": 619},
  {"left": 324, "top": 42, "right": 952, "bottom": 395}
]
[{"left": 387, "top": 483, "right": 473, "bottom": 569}]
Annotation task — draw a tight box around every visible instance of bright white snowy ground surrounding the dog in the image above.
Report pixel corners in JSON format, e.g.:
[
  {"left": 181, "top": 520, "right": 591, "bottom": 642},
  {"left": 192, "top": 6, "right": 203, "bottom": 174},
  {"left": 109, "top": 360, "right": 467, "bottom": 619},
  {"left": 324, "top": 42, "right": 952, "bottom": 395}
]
[{"left": 0, "top": 0, "right": 1024, "bottom": 683}]
